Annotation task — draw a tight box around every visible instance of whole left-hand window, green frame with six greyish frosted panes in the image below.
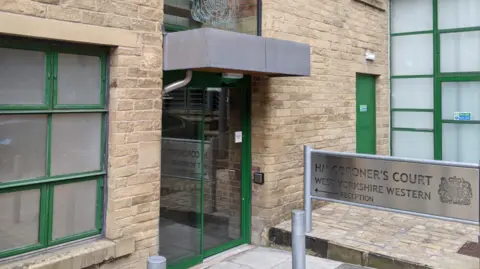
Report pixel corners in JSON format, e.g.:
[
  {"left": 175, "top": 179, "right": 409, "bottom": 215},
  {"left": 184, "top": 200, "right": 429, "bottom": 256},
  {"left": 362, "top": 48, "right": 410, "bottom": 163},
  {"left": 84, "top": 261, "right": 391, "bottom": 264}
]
[{"left": 0, "top": 36, "right": 108, "bottom": 258}]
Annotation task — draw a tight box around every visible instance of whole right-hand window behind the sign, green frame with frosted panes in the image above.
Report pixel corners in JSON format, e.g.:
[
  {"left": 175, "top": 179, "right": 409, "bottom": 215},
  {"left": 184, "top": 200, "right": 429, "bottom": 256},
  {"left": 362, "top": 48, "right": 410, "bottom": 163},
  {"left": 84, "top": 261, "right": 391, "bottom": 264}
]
[{"left": 390, "top": 0, "right": 480, "bottom": 163}]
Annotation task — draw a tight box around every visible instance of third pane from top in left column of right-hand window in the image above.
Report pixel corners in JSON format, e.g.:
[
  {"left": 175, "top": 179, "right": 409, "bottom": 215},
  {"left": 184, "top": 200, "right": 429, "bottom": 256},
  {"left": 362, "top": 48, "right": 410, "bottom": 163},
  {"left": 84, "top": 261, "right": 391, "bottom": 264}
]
[{"left": 392, "top": 78, "right": 433, "bottom": 109}]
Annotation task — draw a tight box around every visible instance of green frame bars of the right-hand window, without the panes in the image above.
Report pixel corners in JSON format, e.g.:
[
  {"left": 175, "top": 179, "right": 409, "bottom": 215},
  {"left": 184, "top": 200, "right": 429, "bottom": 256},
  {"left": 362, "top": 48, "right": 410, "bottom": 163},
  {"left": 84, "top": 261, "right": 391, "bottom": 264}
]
[{"left": 389, "top": 0, "right": 480, "bottom": 160}]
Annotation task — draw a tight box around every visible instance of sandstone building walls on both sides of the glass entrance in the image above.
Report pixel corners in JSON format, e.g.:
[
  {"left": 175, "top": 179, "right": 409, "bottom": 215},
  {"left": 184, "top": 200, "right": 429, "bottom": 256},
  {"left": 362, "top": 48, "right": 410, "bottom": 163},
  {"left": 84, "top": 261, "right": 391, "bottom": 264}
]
[{"left": 0, "top": 0, "right": 390, "bottom": 269}]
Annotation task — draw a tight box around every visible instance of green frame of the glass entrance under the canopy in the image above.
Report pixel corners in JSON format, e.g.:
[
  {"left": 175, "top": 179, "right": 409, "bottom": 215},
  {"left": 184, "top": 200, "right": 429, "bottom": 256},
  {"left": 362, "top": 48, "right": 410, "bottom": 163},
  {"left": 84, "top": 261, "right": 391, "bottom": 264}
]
[{"left": 160, "top": 70, "right": 252, "bottom": 269}]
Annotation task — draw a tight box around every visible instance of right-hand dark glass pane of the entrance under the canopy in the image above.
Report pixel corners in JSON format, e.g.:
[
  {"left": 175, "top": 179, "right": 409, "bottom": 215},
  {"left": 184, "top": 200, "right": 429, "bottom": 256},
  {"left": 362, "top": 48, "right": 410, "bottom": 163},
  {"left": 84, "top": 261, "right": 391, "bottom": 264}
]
[{"left": 204, "top": 88, "right": 242, "bottom": 249}]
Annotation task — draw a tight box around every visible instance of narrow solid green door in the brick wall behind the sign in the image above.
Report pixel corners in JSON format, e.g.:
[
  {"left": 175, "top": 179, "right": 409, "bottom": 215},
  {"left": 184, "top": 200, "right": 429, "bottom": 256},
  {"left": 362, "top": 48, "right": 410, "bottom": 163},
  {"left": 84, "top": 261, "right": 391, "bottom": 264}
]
[{"left": 356, "top": 74, "right": 377, "bottom": 154}]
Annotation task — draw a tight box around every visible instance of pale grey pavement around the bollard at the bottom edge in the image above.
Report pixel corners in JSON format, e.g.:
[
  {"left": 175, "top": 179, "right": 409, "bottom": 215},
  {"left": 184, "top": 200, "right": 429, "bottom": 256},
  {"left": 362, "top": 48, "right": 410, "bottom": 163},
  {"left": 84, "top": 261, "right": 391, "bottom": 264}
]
[{"left": 192, "top": 245, "right": 367, "bottom": 269}]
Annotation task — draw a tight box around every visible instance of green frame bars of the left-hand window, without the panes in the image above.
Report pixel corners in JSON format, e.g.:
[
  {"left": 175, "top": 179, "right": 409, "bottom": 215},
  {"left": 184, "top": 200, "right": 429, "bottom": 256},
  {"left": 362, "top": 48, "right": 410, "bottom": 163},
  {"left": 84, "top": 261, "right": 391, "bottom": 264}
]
[{"left": 0, "top": 36, "right": 109, "bottom": 259}]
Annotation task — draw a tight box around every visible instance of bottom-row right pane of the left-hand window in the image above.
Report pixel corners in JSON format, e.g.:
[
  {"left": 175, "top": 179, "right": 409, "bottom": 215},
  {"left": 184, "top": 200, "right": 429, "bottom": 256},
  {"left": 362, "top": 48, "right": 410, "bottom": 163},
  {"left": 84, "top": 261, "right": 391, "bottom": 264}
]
[{"left": 52, "top": 180, "right": 97, "bottom": 240}]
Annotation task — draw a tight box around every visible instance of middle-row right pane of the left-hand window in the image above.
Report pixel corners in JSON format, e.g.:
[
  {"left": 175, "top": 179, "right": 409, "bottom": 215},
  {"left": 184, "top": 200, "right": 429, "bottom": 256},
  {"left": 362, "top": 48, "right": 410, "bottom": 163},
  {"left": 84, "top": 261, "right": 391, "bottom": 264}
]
[{"left": 50, "top": 113, "right": 103, "bottom": 175}]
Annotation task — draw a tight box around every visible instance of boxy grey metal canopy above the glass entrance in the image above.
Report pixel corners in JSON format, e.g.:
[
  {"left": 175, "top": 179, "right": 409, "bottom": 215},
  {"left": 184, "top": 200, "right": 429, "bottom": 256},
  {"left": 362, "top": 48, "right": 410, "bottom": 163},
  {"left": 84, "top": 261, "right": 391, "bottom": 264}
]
[{"left": 163, "top": 28, "right": 310, "bottom": 77}]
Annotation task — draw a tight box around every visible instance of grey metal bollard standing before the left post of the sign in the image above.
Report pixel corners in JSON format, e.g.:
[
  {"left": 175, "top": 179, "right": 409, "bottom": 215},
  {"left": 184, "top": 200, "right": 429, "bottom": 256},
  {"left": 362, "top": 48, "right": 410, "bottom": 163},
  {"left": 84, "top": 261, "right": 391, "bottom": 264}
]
[{"left": 292, "top": 210, "right": 307, "bottom": 269}]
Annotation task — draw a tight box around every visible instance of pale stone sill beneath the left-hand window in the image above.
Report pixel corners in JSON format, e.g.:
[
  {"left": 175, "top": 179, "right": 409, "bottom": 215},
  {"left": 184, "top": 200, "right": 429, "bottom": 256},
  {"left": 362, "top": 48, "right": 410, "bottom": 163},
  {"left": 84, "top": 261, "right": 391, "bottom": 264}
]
[{"left": 0, "top": 238, "right": 135, "bottom": 269}]
